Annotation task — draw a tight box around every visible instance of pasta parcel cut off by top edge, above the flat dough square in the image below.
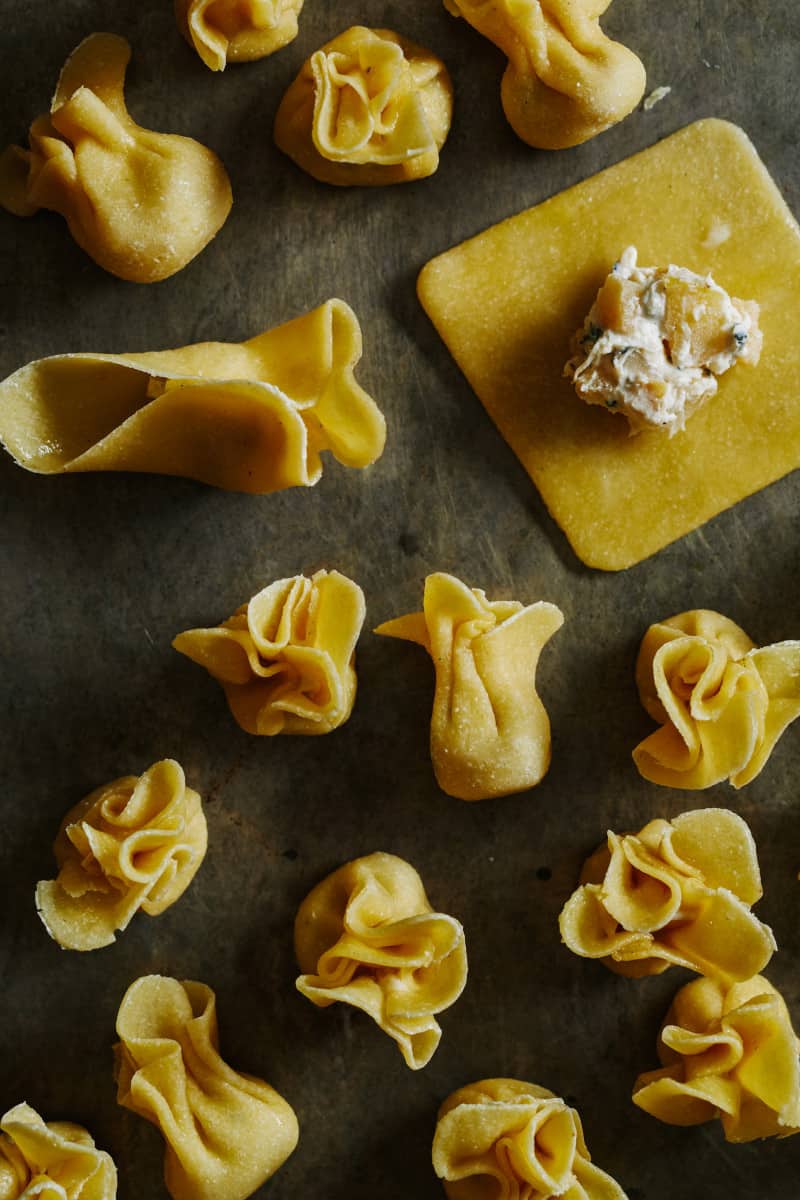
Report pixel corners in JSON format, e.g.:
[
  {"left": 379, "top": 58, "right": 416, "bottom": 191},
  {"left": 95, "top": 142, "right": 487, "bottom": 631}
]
[{"left": 445, "top": 0, "right": 646, "bottom": 150}]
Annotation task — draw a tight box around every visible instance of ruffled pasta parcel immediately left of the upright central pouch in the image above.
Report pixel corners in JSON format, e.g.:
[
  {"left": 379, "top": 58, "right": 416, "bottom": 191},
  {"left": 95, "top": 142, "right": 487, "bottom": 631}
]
[{"left": 173, "top": 571, "right": 366, "bottom": 736}]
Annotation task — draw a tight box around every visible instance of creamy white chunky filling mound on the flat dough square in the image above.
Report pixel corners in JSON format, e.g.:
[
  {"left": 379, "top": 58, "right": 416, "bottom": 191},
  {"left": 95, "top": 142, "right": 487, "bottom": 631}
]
[{"left": 564, "top": 246, "right": 762, "bottom": 436}]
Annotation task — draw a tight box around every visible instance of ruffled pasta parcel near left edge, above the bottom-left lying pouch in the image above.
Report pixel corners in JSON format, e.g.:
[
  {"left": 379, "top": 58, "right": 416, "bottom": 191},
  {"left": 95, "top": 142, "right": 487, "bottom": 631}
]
[{"left": 36, "top": 758, "right": 207, "bottom": 950}]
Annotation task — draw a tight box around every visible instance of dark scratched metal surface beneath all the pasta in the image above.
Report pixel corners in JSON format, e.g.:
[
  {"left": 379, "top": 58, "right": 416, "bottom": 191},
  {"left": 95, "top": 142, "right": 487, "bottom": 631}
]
[{"left": 0, "top": 0, "right": 800, "bottom": 1200}]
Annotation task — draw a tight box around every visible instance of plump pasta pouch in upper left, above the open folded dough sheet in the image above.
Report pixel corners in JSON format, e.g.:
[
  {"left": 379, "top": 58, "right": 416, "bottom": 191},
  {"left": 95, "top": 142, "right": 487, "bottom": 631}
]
[{"left": 0, "top": 34, "right": 233, "bottom": 283}]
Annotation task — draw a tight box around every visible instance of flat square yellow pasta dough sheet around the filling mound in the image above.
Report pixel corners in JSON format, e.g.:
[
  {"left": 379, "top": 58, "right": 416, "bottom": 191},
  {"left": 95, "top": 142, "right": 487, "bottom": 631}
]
[{"left": 419, "top": 120, "right": 800, "bottom": 570}]
